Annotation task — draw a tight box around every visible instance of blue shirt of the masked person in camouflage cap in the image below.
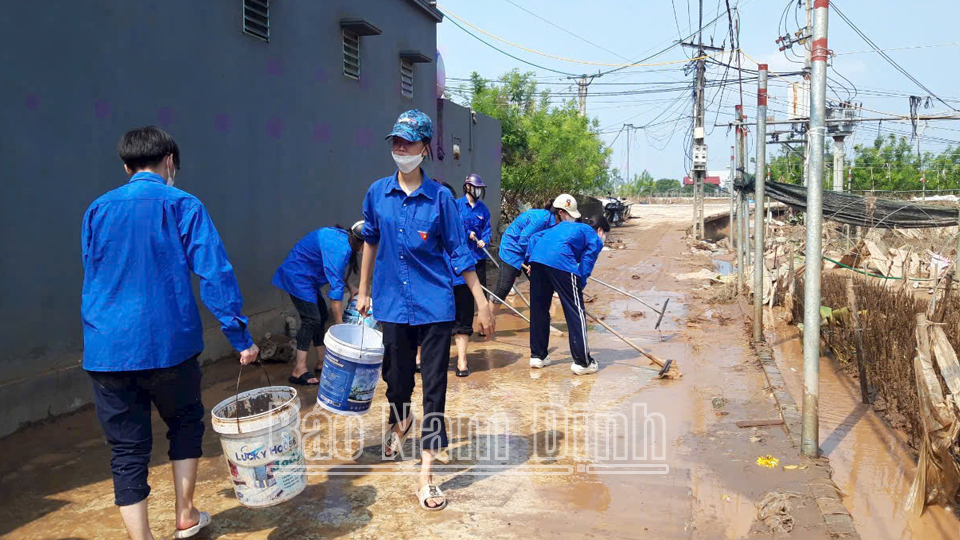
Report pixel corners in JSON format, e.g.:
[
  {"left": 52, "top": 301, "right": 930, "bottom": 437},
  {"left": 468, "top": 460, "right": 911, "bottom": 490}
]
[{"left": 363, "top": 170, "right": 476, "bottom": 325}]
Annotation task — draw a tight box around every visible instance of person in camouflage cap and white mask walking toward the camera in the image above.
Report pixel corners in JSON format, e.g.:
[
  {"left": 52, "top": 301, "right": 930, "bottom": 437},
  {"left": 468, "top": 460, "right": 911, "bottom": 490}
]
[{"left": 357, "top": 110, "right": 494, "bottom": 510}]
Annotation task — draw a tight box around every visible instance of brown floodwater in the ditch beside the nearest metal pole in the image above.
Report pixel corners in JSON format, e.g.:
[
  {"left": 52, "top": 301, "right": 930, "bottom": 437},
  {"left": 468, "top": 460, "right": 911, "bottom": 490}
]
[{"left": 768, "top": 318, "right": 960, "bottom": 540}]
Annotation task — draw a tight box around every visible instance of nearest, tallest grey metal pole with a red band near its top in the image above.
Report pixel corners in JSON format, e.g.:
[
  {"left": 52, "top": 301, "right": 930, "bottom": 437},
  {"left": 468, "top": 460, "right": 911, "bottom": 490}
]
[{"left": 800, "top": 0, "right": 830, "bottom": 457}]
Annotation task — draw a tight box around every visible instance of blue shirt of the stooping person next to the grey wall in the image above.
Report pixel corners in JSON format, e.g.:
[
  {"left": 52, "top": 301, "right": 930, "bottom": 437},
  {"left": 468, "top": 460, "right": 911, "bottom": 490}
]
[{"left": 273, "top": 227, "right": 352, "bottom": 304}]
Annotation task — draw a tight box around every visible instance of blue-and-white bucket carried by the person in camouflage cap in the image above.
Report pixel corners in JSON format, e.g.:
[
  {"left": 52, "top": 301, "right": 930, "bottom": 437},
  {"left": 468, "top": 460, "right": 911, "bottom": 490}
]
[{"left": 317, "top": 324, "right": 383, "bottom": 415}]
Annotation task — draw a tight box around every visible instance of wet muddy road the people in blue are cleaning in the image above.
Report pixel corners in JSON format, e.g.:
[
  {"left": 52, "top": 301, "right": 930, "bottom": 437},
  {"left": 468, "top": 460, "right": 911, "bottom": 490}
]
[{"left": 0, "top": 205, "right": 828, "bottom": 540}]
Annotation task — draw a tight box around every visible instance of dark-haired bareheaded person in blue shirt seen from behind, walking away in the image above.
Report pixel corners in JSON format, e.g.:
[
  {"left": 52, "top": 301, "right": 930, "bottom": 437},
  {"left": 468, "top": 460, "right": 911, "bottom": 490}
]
[{"left": 80, "top": 126, "right": 259, "bottom": 540}]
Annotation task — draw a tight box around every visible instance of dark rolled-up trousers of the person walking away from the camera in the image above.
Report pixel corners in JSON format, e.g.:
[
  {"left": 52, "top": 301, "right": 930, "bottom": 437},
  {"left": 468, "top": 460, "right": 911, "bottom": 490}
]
[{"left": 87, "top": 356, "right": 204, "bottom": 506}]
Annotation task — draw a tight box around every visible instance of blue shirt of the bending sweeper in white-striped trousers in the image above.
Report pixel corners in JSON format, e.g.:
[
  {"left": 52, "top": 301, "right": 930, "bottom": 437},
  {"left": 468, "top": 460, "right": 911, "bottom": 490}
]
[{"left": 527, "top": 221, "right": 603, "bottom": 284}]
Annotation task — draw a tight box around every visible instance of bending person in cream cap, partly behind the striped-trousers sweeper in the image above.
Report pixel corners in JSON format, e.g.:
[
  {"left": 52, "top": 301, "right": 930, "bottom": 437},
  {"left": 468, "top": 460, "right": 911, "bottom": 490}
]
[{"left": 493, "top": 193, "right": 580, "bottom": 315}]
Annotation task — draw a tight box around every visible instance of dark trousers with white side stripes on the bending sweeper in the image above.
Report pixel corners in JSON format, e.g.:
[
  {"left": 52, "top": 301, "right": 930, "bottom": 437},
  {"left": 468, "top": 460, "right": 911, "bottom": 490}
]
[{"left": 530, "top": 263, "right": 593, "bottom": 367}]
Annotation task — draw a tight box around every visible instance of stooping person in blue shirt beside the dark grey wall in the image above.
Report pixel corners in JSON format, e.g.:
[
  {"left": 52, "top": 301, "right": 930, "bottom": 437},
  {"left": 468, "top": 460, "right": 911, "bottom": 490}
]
[{"left": 273, "top": 221, "right": 363, "bottom": 385}]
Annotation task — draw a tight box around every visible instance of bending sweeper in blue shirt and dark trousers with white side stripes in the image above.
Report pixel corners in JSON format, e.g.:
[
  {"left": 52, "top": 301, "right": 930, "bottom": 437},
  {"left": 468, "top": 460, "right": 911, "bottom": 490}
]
[{"left": 526, "top": 216, "right": 610, "bottom": 375}]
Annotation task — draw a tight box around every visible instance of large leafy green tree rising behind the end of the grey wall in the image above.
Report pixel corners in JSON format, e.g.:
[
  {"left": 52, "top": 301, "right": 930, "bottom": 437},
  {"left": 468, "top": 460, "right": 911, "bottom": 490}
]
[{"left": 470, "top": 69, "right": 614, "bottom": 221}]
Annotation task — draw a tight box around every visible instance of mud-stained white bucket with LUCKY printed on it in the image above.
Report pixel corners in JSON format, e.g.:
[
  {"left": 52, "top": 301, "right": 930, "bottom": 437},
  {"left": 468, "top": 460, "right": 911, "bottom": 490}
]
[{"left": 210, "top": 386, "right": 307, "bottom": 508}]
